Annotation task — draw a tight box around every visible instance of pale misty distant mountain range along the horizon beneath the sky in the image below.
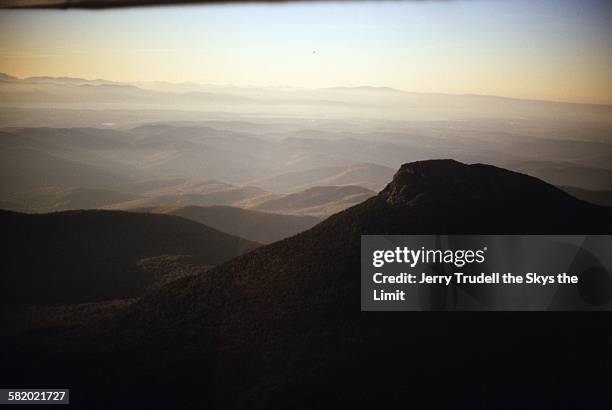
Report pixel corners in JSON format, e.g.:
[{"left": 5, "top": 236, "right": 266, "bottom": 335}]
[{"left": 0, "top": 74, "right": 612, "bottom": 121}]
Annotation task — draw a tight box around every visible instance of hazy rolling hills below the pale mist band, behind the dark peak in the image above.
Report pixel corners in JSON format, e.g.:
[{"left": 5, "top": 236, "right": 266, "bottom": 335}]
[{"left": 0, "top": 121, "right": 612, "bottom": 218}]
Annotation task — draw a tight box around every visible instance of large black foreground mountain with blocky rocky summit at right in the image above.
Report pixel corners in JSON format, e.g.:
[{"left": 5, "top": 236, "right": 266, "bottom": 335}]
[{"left": 0, "top": 160, "right": 612, "bottom": 409}]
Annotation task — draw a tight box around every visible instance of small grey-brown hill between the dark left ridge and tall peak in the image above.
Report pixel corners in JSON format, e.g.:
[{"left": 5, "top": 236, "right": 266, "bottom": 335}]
[{"left": 146, "top": 206, "right": 319, "bottom": 243}]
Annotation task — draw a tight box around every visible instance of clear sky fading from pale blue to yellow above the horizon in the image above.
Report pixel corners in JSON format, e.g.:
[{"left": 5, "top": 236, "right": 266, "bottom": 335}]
[{"left": 0, "top": 0, "right": 612, "bottom": 104}]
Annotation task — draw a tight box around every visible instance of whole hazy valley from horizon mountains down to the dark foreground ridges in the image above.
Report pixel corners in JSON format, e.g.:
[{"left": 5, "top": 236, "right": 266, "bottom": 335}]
[{"left": 0, "top": 76, "right": 612, "bottom": 218}]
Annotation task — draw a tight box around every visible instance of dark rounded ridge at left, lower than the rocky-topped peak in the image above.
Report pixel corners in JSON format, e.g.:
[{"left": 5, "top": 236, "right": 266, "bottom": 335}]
[{"left": 0, "top": 211, "right": 257, "bottom": 308}]
